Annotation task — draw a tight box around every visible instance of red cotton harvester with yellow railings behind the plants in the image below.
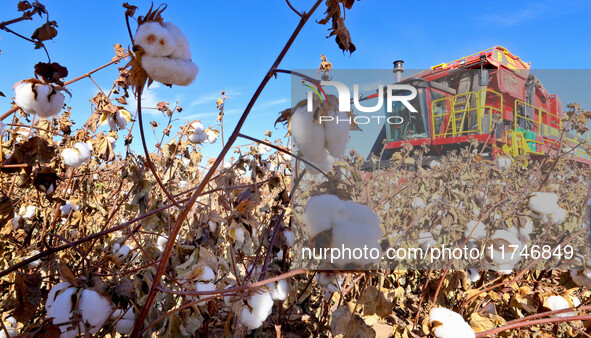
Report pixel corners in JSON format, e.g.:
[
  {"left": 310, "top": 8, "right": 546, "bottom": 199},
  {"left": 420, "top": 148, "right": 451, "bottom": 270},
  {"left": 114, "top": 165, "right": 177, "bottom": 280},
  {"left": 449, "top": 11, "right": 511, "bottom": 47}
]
[{"left": 364, "top": 46, "right": 591, "bottom": 164}]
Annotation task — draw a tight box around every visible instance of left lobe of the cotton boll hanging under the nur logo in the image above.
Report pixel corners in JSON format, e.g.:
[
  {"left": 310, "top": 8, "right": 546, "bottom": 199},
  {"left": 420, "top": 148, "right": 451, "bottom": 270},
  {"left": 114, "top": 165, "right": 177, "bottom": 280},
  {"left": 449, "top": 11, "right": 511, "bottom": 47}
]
[{"left": 290, "top": 106, "right": 327, "bottom": 163}]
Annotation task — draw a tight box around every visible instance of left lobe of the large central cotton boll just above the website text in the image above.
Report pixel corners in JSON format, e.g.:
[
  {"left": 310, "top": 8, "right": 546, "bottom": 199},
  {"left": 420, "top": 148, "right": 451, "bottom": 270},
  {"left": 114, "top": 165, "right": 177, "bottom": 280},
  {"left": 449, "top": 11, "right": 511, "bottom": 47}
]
[{"left": 302, "top": 194, "right": 349, "bottom": 238}]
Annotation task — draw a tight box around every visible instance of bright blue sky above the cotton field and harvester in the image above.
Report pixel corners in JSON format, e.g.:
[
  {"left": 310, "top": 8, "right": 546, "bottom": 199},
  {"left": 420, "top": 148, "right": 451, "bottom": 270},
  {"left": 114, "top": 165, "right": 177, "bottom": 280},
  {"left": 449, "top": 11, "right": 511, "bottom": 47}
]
[{"left": 0, "top": 0, "right": 591, "bottom": 156}]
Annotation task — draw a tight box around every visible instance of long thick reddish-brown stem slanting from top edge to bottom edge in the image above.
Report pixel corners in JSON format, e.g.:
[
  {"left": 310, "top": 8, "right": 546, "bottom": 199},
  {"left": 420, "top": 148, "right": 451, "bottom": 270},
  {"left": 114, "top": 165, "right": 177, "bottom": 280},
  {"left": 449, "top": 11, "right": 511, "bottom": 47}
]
[{"left": 131, "top": 0, "right": 322, "bottom": 338}]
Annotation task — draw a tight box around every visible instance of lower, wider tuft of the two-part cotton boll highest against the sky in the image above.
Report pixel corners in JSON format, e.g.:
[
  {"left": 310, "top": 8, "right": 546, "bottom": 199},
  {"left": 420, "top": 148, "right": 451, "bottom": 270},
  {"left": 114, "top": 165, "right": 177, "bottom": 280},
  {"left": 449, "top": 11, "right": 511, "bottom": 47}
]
[{"left": 142, "top": 55, "right": 199, "bottom": 86}]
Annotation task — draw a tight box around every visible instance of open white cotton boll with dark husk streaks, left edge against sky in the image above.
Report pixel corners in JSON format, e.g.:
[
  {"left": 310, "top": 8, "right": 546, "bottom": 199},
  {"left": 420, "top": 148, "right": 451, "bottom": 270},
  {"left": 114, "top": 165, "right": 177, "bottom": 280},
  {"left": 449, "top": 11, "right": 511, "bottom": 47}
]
[{"left": 14, "top": 79, "right": 65, "bottom": 118}]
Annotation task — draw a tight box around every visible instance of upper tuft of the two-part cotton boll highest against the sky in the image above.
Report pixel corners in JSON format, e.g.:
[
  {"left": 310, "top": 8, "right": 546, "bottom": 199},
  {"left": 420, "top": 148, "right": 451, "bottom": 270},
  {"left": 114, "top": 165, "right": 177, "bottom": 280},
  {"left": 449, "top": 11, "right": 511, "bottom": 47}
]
[{"left": 134, "top": 21, "right": 177, "bottom": 56}]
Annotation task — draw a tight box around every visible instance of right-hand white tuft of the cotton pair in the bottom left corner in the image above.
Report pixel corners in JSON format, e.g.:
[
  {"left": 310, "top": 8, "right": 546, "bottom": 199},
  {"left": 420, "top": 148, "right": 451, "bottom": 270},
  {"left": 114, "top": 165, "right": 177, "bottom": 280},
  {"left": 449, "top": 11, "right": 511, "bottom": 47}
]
[{"left": 78, "top": 289, "right": 112, "bottom": 334}]
